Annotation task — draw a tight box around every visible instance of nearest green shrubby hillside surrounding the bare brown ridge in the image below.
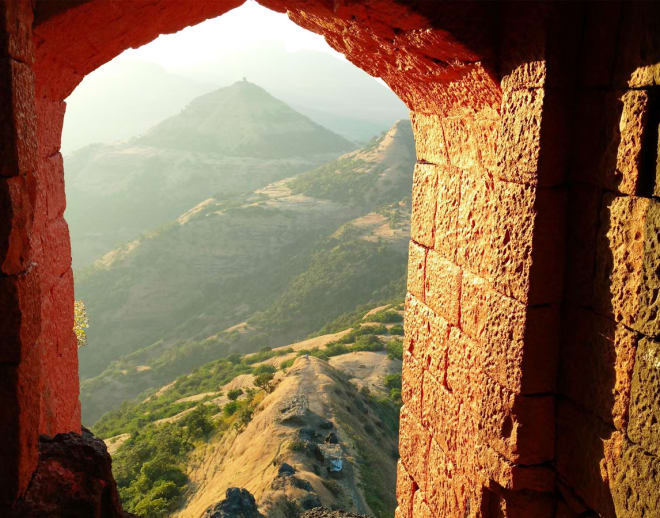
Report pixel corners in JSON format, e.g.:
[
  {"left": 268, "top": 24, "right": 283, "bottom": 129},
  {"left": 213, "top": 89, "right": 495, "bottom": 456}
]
[{"left": 94, "top": 304, "right": 402, "bottom": 518}]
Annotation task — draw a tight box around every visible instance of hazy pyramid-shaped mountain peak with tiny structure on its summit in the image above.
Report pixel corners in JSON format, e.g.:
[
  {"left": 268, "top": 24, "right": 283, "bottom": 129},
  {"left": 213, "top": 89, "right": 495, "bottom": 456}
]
[{"left": 137, "top": 80, "right": 354, "bottom": 158}]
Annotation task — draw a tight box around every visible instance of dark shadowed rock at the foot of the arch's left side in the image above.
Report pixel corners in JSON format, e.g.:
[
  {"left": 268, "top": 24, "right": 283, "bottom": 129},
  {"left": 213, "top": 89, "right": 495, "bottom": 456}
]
[{"left": 15, "top": 428, "right": 133, "bottom": 518}]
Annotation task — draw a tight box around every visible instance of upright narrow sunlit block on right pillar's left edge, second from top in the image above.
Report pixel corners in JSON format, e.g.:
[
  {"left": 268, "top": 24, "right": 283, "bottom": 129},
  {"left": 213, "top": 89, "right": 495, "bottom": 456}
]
[{"left": 410, "top": 164, "right": 438, "bottom": 248}]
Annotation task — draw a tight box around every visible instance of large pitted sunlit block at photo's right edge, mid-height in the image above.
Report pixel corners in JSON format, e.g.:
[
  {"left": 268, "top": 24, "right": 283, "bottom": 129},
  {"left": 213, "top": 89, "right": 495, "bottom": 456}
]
[{"left": 594, "top": 194, "right": 660, "bottom": 337}]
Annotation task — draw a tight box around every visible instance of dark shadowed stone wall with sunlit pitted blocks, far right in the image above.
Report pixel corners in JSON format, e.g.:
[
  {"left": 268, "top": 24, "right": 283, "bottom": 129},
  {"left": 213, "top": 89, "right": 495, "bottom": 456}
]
[{"left": 556, "top": 3, "right": 660, "bottom": 518}]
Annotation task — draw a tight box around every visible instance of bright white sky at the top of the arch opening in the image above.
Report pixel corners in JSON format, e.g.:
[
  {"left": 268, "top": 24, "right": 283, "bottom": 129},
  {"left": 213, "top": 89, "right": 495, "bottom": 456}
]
[{"left": 123, "top": 0, "right": 344, "bottom": 70}]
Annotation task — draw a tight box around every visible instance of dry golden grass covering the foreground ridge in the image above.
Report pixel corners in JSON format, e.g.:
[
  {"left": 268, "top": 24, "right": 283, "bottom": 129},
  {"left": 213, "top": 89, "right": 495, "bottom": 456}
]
[{"left": 173, "top": 353, "right": 401, "bottom": 518}]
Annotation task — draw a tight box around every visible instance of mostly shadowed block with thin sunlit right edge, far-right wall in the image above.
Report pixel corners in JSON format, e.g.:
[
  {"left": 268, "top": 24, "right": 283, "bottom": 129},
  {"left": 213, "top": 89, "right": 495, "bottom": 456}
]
[{"left": 558, "top": 306, "right": 636, "bottom": 430}]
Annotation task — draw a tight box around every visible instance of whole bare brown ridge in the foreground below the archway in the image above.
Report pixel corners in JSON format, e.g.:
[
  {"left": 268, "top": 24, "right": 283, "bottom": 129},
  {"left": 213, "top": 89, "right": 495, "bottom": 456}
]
[{"left": 173, "top": 354, "right": 400, "bottom": 518}]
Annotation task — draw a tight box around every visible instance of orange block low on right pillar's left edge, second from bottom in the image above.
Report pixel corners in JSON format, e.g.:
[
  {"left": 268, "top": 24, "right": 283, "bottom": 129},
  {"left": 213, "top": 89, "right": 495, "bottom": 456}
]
[{"left": 399, "top": 405, "right": 431, "bottom": 489}]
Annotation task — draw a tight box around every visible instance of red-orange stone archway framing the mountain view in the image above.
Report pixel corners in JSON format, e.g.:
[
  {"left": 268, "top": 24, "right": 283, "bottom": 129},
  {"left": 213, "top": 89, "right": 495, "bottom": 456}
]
[{"left": 0, "top": 0, "right": 660, "bottom": 518}]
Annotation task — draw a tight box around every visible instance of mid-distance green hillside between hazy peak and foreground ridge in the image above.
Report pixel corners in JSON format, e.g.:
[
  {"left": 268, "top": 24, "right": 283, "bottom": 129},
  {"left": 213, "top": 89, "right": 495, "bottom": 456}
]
[{"left": 76, "top": 105, "right": 414, "bottom": 423}]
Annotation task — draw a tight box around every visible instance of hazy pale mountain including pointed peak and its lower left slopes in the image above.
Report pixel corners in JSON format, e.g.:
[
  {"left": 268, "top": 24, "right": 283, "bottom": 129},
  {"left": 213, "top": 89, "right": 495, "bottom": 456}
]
[{"left": 64, "top": 81, "right": 354, "bottom": 269}]
